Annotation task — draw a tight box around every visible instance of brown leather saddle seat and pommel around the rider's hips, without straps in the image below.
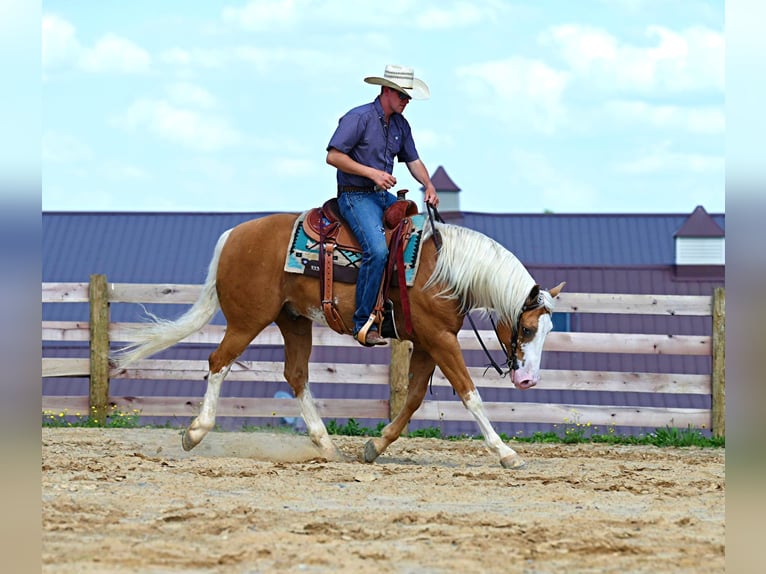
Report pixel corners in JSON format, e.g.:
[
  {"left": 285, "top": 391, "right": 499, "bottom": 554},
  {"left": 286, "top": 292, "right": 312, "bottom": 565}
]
[{"left": 303, "top": 197, "right": 418, "bottom": 253}]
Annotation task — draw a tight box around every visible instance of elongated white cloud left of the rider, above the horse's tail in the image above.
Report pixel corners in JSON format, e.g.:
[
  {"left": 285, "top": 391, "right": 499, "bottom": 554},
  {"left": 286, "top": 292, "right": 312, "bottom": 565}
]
[{"left": 113, "top": 99, "right": 242, "bottom": 152}]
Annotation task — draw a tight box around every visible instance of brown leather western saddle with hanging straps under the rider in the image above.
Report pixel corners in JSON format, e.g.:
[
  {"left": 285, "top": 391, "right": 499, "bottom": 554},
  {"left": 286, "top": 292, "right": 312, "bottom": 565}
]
[{"left": 303, "top": 189, "right": 418, "bottom": 338}]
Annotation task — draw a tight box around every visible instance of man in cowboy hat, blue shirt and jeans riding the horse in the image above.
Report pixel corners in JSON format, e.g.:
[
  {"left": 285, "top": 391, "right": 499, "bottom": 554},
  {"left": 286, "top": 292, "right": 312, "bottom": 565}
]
[{"left": 327, "top": 65, "right": 439, "bottom": 347}]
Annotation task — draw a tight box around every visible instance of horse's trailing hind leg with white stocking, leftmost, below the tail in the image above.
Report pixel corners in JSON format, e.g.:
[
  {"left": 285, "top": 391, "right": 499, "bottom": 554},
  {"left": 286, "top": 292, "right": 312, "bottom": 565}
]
[{"left": 181, "top": 327, "right": 254, "bottom": 450}]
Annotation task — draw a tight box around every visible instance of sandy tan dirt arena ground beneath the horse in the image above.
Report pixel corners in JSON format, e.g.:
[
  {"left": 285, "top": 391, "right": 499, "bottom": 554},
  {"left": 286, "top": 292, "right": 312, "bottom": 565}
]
[{"left": 42, "top": 428, "right": 725, "bottom": 574}]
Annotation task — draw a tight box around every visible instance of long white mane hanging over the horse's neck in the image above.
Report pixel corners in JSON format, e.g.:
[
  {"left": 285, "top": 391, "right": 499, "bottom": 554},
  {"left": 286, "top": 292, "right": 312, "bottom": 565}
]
[{"left": 423, "top": 223, "right": 540, "bottom": 322}]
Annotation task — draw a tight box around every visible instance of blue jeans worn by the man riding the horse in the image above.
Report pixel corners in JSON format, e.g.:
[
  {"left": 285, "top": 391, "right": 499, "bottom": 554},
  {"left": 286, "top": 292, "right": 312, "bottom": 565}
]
[{"left": 338, "top": 191, "right": 396, "bottom": 335}]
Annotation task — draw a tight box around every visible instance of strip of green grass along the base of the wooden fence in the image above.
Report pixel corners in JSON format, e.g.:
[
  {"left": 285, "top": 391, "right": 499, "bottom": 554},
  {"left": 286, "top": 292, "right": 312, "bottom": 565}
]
[{"left": 42, "top": 414, "right": 726, "bottom": 448}]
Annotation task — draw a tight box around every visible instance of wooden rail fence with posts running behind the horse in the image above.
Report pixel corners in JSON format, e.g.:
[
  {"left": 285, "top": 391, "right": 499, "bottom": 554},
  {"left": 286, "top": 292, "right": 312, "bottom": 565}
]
[{"left": 42, "top": 275, "right": 725, "bottom": 436}]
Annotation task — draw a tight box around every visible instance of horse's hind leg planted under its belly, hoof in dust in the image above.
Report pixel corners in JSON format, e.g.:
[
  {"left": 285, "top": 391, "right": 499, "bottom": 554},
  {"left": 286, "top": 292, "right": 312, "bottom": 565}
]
[{"left": 276, "top": 310, "right": 344, "bottom": 460}]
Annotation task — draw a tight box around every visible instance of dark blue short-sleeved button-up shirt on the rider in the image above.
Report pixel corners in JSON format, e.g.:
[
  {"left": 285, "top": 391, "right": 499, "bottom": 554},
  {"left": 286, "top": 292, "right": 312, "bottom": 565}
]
[{"left": 327, "top": 97, "right": 419, "bottom": 187}]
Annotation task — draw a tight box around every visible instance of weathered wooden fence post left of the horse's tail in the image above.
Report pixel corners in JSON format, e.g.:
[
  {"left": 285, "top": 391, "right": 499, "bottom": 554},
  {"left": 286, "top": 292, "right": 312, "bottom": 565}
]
[{"left": 88, "top": 275, "right": 109, "bottom": 426}]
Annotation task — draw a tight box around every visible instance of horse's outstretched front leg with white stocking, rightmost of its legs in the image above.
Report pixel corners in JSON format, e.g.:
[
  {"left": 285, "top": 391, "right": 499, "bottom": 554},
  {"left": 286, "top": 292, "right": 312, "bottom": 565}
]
[{"left": 431, "top": 337, "right": 524, "bottom": 468}]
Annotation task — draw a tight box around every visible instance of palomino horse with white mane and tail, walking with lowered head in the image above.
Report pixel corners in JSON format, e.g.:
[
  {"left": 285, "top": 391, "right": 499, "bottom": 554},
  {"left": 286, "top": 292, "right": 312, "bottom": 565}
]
[{"left": 113, "top": 214, "right": 564, "bottom": 468}]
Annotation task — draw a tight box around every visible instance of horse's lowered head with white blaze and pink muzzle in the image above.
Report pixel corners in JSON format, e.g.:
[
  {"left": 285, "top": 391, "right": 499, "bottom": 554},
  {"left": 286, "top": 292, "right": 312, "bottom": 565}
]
[{"left": 497, "top": 282, "right": 566, "bottom": 390}]
